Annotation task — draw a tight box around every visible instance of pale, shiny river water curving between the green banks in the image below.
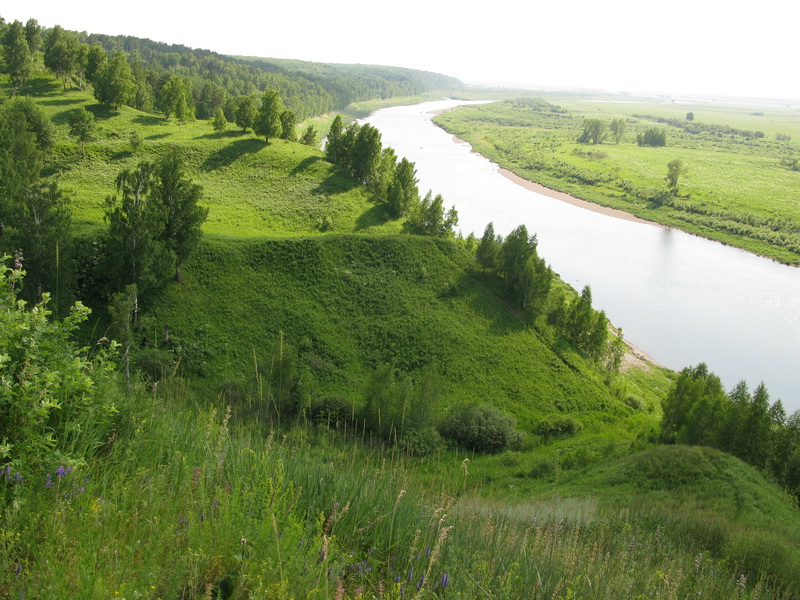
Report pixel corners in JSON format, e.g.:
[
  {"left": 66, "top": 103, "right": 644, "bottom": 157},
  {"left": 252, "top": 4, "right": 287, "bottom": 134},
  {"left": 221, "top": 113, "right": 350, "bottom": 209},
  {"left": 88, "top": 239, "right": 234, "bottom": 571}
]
[{"left": 365, "top": 100, "right": 800, "bottom": 413}]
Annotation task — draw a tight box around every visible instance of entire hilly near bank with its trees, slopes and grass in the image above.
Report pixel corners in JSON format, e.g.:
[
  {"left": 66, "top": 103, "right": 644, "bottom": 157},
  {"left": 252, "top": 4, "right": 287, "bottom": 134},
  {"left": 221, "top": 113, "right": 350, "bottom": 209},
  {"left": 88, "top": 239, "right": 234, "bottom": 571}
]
[{"left": 0, "top": 14, "right": 800, "bottom": 600}]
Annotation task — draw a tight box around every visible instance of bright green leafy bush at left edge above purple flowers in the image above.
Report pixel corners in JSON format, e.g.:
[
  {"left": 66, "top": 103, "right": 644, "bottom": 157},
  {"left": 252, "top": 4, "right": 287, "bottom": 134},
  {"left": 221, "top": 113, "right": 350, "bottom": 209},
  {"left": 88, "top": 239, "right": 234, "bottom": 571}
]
[{"left": 0, "top": 264, "right": 115, "bottom": 473}]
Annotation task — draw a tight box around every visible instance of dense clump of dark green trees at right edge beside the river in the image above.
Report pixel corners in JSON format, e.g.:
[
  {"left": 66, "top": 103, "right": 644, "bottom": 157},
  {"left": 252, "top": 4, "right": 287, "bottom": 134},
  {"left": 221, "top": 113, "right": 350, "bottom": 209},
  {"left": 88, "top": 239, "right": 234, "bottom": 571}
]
[{"left": 660, "top": 363, "right": 800, "bottom": 504}]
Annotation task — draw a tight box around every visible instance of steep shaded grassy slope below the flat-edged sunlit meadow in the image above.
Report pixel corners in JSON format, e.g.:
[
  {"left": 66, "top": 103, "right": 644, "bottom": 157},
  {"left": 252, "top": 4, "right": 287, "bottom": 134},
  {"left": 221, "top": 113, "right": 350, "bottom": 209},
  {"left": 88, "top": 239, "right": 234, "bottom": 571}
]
[{"left": 150, "top": 235, "right": 652, "bottom": 429}]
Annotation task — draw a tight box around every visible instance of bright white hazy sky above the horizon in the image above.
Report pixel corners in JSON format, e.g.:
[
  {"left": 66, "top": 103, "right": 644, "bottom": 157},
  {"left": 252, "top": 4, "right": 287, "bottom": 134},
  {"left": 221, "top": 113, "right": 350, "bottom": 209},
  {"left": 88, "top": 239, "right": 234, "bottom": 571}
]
[{"left": 0, "top": 0, "right": 800, "bottom": 99}]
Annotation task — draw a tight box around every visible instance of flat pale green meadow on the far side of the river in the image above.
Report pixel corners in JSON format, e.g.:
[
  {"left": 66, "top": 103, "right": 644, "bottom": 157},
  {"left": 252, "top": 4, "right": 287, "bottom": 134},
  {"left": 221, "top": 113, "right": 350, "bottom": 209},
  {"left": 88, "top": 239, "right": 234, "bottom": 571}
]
[{"left": 435, "top": 98, "right": 800, "bottom": 264}]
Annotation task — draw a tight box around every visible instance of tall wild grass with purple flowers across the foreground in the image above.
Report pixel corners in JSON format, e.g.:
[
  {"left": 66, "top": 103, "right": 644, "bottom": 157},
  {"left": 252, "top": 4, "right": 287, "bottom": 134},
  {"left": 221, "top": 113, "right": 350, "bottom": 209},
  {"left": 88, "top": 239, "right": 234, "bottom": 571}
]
[{"left": 0, "top": 379, "right": 798, "bottom": 599}]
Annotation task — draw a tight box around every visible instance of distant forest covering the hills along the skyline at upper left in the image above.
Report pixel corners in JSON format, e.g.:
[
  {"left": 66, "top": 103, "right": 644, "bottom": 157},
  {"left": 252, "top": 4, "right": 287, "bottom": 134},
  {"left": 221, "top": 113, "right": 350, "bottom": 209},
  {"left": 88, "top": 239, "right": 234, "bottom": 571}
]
[{"left": 0, "top": 17, "right": 463, "bottom": 122}]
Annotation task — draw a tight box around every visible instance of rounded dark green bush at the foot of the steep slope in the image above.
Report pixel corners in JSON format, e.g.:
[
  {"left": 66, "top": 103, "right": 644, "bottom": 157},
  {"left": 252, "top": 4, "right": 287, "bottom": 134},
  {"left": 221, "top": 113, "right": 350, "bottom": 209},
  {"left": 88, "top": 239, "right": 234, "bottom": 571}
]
[{"left": 439, "top": 404, "right": 522, "bottom": 452}]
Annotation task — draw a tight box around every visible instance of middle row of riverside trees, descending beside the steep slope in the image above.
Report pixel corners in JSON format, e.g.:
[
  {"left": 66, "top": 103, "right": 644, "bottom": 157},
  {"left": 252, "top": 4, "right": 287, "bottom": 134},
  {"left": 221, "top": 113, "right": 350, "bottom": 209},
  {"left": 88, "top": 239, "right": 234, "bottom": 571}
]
[{"left": 475, "top": 223, "right": 621, "bottom": 369}]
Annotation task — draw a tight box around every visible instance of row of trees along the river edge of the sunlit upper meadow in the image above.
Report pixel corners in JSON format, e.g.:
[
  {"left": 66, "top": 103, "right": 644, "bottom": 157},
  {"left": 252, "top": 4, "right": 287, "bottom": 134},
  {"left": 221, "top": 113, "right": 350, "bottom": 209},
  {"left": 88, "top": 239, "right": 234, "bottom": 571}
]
[{"left": 325, "top": 115, "right": 458, "bottom": 237}]
